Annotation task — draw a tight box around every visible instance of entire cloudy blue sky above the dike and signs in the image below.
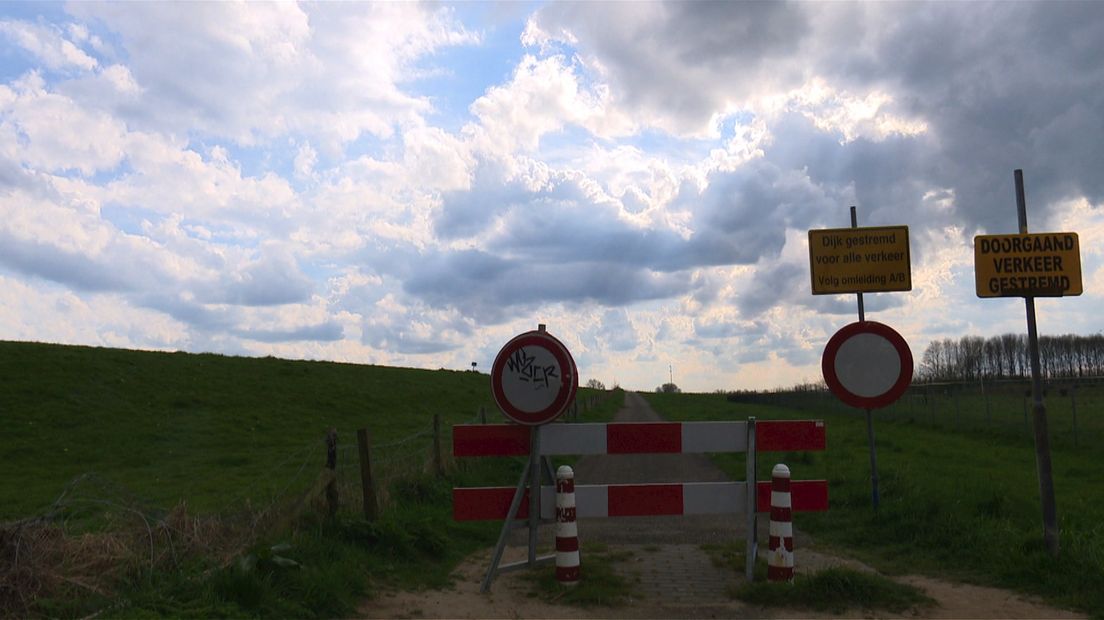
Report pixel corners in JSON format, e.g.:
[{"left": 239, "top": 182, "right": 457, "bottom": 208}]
[{"left": 0, "top": 2, "right": 1104, "bottom": 392}]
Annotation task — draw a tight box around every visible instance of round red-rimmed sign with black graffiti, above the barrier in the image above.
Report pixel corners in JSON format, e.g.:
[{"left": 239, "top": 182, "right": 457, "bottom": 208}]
[{"left": 490, "top": 330, "right": 578, "bottom": 426}]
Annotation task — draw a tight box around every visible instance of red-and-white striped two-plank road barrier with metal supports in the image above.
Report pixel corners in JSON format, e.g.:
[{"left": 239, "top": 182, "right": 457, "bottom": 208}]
[{"left": 453, "top": 418, "right": 828, "bottom": 592}]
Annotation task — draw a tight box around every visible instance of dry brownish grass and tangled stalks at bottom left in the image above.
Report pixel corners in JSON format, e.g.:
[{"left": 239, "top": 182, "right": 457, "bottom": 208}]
[{"left": 0, "top": 467, "right": 333, "bottom": 618}]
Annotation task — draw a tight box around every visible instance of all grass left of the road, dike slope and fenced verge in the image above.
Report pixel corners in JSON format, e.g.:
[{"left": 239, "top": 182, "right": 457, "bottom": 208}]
[{"left": 0, "top": 342, "right": 620, "bottom": 618}]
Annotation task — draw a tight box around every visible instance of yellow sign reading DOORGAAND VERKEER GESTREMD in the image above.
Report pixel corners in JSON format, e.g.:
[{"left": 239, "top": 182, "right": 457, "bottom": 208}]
[{"left": 974, "top": 233, "right": 1081, "bottom": 297}]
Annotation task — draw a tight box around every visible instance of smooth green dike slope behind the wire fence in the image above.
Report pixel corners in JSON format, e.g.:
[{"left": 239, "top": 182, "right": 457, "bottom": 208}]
[{"left": 0, "top": 342, "right": 505, "bottom": 520}]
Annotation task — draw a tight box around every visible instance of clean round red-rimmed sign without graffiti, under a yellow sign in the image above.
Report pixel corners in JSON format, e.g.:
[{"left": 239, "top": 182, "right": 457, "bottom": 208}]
[{"left": 820, "top": 321, "right": 912, "bottom": 409}]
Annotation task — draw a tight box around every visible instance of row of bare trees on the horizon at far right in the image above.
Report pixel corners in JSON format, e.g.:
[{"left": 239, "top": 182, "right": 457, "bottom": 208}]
[{"left": 916, "top": 333, "right": 1104, "bottom": 382}]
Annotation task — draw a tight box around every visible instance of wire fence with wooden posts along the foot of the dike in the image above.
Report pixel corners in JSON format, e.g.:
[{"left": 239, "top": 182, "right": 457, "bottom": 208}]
[{"left": 0, "top": 393, "right": 611, "bottom": 618}]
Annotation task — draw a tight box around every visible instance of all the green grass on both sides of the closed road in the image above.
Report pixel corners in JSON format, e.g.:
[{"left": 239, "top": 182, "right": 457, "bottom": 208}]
[{"left": 0, "top": 342, "right": 1104, "bottom": 618}]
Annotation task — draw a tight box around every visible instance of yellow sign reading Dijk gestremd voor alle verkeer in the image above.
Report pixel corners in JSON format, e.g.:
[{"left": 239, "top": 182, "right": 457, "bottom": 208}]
[{"left": 809, "top": 226, "right": 912, "bottom": 295}]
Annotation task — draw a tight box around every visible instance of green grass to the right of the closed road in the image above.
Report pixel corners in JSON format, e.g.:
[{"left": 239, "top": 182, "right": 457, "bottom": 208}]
[{"left": 648, "top": 395, "right": 1104, "bottom": 613}]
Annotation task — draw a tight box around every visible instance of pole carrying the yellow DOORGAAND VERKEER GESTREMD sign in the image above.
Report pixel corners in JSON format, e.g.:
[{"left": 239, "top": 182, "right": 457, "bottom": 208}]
[{"left": 1015, "top": 170, "right": 1058, "bottom": 556}]
